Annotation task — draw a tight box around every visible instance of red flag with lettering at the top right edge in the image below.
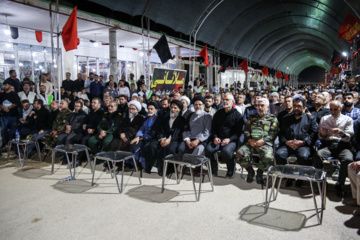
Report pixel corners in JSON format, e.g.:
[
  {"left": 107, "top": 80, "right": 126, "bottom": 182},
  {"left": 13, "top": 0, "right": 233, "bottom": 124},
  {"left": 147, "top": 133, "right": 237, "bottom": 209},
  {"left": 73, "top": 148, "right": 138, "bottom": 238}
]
[{"left": 338, "top": 13, "right": 360, "bottom": 43}]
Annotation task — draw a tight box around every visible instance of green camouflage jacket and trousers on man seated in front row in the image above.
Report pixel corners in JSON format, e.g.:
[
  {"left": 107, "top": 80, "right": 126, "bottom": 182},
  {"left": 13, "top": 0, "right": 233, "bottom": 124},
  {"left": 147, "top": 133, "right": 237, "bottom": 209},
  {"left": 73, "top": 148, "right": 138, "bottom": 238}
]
[{"left": 236, "top": 113, "right": 279, "bottom": 171}]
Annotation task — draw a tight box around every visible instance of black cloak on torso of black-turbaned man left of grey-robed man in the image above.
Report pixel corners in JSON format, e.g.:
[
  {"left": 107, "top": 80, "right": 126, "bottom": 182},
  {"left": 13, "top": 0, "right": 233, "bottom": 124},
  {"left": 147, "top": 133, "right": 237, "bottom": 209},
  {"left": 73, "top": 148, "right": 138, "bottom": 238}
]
[{"left": 157, "top": 115, "right": 186, "bottom": 142}]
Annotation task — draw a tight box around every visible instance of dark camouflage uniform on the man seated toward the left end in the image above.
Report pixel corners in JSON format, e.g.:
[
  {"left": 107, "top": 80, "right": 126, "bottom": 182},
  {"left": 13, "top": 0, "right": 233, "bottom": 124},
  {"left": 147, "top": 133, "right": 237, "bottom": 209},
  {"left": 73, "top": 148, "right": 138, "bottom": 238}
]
[{"left": 42, "top": 108, "right": 72, "bottom": 147}]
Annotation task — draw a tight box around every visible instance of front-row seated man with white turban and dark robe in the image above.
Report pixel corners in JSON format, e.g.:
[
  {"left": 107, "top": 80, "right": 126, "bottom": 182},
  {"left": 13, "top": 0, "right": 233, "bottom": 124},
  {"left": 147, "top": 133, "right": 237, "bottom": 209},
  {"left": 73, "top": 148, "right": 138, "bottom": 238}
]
[{"left": 110, "top": 100, "right": 144, "bottom": 151}]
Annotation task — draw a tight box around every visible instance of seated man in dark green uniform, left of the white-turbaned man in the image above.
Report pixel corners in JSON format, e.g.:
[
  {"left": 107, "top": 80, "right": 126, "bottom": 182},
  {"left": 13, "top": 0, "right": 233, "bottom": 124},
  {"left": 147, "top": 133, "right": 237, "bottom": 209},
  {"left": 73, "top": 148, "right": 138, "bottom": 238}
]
[{"left": 89, "top": 101, "right": 123, "bottom": 154}]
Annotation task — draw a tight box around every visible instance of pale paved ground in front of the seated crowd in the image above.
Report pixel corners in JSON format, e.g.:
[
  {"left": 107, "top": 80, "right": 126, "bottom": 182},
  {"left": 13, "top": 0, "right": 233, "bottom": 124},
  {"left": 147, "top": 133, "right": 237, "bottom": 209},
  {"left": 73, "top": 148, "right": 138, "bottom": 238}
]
[{"left": 0, "top": 154, "right": 360, "bottom": 240}]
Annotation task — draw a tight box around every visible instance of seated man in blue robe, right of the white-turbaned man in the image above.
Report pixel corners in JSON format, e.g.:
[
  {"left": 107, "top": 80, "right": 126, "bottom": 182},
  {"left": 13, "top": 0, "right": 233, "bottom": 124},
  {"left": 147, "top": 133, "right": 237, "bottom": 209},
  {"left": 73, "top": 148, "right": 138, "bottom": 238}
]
[{"left": 130, "top": 102, "right": 159, "bottom": 174}]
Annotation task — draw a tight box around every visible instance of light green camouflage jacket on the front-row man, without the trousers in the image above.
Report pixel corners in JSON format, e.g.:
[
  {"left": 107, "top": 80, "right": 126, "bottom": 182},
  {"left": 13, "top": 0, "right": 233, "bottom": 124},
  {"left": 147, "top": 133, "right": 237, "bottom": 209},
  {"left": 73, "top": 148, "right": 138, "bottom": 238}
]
[{"left": 244, "top": 113, "right": 279, "bottom": 146}]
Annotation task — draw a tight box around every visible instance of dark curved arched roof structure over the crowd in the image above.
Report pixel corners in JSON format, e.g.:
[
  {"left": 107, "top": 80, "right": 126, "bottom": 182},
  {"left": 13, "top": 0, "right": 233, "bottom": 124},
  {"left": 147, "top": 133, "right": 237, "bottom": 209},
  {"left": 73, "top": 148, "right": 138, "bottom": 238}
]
[{"left": 60, "top": 0, "right": 360, "bottom": 75}]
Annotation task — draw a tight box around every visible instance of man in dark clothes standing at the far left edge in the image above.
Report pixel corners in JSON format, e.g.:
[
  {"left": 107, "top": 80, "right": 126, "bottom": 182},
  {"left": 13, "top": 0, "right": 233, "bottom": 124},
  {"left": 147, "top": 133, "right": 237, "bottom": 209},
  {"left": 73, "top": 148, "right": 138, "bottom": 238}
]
[{"left": 0, "top": 79, "right": 21, "bottom": 147}]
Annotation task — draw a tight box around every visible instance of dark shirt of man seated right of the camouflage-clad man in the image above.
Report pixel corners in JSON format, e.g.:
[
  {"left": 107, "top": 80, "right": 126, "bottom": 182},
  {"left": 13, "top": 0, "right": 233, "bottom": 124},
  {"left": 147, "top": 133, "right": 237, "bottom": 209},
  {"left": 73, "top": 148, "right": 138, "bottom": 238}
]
[{"left": 279, "top": 113, "right": 318, "bottom": 147}]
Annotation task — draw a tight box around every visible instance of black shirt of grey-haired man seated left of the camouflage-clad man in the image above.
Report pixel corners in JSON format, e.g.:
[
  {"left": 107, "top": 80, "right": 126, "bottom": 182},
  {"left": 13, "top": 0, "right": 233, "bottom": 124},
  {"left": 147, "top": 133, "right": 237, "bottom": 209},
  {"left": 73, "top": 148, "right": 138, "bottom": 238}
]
[{"left": 211, "top": 108, "right": 244, "bottom": 142}]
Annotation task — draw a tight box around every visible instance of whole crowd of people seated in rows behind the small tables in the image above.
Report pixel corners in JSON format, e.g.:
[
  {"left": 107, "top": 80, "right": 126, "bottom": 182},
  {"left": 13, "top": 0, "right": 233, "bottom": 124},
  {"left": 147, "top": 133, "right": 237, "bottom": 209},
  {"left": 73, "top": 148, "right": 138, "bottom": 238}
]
[{"left": 0, "top": 70, "right": 360, "bottom": 209}]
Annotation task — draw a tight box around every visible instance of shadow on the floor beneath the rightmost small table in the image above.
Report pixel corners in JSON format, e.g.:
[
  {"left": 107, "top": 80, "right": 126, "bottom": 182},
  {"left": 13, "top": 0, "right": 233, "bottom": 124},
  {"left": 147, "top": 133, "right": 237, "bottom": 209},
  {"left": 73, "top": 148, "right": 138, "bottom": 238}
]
[{"left": 240, "top": 205, "right": 306, "bottom": 231}]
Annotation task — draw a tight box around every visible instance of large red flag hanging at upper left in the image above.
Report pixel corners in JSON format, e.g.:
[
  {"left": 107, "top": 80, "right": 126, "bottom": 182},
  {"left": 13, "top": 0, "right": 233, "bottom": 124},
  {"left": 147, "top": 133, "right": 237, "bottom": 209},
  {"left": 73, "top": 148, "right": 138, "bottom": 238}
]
[{"left": 61, "top": 7, "right": 78, "bottom": 51}]
